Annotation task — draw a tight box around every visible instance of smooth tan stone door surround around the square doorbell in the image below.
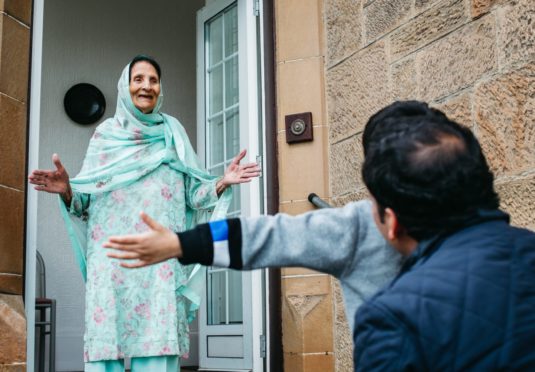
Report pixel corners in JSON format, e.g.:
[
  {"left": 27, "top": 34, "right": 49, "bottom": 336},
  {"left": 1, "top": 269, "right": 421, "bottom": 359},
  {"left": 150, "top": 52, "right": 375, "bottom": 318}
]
[{"left": 274, "top": 0, "right": 336, "bottom": 372}]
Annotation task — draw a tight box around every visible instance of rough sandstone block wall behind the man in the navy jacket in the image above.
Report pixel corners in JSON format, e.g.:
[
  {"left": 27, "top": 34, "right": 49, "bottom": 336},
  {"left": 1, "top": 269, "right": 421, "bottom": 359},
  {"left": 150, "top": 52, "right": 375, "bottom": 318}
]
[{"left": 324, "top": 0, "right": 535, "bottom": 371}]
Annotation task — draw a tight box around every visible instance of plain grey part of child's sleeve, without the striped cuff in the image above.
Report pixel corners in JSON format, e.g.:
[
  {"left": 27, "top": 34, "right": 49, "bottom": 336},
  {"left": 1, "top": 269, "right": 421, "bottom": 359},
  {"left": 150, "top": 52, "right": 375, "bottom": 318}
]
[{"left": 241, "top": 201, "right": 375, "bottom": 277}]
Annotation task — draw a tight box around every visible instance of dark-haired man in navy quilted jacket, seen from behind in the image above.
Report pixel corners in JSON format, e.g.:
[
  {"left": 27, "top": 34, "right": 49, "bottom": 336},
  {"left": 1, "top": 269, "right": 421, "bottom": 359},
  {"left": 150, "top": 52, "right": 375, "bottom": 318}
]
[{"left": 354, "top": 102, "right": 535, "bottom": 371}]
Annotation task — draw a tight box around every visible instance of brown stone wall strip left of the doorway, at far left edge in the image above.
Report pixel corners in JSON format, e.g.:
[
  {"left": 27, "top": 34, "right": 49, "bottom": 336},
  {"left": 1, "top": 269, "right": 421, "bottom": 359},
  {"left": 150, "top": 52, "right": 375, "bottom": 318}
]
[{"left": 0, "top": 0, "right": 31, "bottom": 371}]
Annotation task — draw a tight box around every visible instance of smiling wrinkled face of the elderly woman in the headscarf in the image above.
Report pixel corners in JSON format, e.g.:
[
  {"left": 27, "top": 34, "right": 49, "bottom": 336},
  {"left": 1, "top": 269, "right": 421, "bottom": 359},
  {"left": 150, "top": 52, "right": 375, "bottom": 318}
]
[{"left": 130, "top": 61, "right": 160, "bottom": 114}]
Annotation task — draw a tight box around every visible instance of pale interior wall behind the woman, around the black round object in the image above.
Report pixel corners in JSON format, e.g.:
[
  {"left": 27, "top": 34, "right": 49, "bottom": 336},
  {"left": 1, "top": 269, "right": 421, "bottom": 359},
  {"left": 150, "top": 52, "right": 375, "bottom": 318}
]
[{"left": 37, "top": 0, "right": 204, "bottom": 371}]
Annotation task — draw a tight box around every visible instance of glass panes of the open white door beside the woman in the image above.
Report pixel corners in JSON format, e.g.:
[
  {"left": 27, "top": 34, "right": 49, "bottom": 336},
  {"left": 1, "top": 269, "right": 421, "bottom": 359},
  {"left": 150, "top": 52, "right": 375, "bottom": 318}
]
[{"left": 205, "top": 3, "right": 243, "bottom": 334}]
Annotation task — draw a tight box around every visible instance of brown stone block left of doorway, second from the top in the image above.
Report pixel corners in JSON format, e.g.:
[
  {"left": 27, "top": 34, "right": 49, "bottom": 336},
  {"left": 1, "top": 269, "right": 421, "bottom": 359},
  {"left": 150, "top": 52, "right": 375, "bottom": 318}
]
[{"left": 0, "top": 14, "right": 30, "bottom": 102}]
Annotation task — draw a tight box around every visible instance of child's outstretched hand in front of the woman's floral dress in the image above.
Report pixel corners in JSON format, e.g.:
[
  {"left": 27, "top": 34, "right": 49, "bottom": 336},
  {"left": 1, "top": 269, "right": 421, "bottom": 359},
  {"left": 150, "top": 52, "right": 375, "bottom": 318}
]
[{"left": 104, "top": 212, "right": 182, "bottom": 268}]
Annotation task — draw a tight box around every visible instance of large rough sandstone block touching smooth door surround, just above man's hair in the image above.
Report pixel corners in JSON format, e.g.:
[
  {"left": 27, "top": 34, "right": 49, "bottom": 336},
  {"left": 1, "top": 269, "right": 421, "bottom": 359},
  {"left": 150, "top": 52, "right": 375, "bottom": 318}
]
[{"left": 326, "top": 42, "right": 392, "bottom": 143}]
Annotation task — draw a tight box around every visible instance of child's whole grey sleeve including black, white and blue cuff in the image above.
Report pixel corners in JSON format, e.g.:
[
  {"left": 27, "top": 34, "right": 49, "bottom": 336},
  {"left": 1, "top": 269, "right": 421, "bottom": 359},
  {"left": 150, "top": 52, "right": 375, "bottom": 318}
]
[{"left": 179, "top": 201, "right": 385, "bottom": 277}]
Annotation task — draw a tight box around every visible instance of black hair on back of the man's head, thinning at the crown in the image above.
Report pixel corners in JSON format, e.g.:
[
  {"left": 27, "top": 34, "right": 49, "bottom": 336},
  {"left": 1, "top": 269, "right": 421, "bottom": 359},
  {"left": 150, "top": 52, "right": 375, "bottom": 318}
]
[{"left": 362, "top": 101, "right": 498, "bottom": 240}]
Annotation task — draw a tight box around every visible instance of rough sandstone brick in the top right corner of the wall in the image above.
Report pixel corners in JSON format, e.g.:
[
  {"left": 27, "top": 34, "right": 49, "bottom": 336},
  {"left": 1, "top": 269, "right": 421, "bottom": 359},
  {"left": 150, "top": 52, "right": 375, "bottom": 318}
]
[{"left": 497, "top": 0, "right": 535, "bottom": 66}]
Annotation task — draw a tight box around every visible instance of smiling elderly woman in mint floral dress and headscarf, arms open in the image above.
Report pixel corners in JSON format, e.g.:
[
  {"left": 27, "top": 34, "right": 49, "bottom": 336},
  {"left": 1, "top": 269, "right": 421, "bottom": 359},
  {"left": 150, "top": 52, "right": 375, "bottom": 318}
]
[{"left": 29, "top": 56, "right": 259, "bottom": 371}]
